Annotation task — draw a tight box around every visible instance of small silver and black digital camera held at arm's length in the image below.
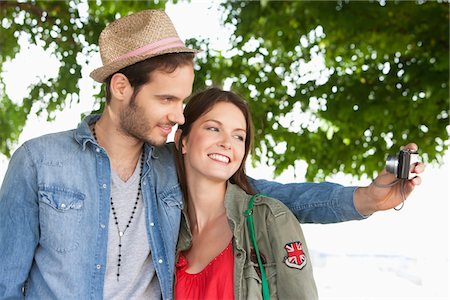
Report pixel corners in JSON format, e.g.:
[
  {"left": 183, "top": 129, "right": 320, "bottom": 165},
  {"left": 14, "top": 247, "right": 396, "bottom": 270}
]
[{"left": 386, "top": 150, "right": 419, "bottom": 179}]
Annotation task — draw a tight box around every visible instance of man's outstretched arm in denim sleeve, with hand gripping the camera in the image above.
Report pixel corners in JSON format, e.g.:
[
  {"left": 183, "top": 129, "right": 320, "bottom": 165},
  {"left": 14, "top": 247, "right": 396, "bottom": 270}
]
[{"left": 249, "top": 144, "right": 424, "bottom": 223}]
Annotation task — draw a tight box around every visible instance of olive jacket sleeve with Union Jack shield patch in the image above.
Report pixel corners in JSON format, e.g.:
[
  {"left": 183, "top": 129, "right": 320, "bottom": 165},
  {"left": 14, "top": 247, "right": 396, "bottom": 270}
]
[{"left": 266, "top": 202, "right": 318, "bottom": 300}]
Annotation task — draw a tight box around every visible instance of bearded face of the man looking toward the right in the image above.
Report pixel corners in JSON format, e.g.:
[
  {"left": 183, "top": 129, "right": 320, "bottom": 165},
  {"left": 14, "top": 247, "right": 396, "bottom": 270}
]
[{"left": 120, "top": 65, "right": 194, "bottom": 146}]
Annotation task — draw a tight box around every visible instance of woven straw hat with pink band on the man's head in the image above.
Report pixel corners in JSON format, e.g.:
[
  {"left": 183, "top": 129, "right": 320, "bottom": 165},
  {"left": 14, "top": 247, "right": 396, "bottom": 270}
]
[{"left": 90, "top": 10, "right": 198, "bottom": 82}]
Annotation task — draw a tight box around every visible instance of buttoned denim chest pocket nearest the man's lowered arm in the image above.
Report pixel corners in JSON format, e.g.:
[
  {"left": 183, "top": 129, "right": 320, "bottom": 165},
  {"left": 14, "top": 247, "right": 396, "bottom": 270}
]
[{"left": 38, "top": 186, "right": 85, "bottom": 253}]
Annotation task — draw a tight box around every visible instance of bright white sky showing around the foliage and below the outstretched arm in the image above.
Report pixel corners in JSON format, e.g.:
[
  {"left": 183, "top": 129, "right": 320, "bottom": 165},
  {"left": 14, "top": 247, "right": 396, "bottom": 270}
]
[{"left": 0, "top": 1, "right": 450, "bottom": 299}]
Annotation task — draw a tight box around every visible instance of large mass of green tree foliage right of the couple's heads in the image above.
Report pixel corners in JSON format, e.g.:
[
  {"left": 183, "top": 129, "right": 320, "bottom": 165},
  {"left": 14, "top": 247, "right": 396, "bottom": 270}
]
[{"left": 197, "top": 1, "right": 450, "bottom": 179}]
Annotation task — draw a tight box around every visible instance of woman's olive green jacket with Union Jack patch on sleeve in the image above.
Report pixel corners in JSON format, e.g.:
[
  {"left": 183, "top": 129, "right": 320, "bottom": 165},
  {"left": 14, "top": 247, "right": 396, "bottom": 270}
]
[{"left": 177, "top": 183, "right": 318, "bottom": 300}]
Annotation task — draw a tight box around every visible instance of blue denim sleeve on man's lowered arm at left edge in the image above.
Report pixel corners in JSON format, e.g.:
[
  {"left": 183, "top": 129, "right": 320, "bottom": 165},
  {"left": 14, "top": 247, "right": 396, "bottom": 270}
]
[{"left": 0, "top": 145, "right": 39, "bottom": 299}]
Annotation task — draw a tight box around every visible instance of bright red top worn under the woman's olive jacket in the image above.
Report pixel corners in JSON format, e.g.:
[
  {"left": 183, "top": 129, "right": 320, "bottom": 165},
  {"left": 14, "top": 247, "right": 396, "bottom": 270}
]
[{"left": 175, "top": 241, "right": 234, "bottom": 300}]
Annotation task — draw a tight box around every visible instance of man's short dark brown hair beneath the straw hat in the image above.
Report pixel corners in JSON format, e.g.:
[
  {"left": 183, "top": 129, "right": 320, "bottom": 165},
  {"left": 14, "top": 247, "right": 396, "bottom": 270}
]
[{"left": 105, "top": 52, "right": 194, "bottom": 103}]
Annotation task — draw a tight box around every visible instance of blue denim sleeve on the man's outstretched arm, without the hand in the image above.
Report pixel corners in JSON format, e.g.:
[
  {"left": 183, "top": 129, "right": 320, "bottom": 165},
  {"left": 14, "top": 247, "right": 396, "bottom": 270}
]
[{"left": 249, "top": 177, "right": 366, "bottom": 224}]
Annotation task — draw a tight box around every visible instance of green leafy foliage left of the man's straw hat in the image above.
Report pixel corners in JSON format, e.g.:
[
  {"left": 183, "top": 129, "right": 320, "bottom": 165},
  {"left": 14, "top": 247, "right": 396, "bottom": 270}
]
[{"left": 0, "top": 0, "right": 167, "bottom": 156}]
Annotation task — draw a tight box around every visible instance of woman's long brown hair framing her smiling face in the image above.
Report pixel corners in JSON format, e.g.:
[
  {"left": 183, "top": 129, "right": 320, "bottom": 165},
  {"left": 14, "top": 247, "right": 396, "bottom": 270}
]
[{"left": 175, "top": 87, "right": 254, "bottom": 201}]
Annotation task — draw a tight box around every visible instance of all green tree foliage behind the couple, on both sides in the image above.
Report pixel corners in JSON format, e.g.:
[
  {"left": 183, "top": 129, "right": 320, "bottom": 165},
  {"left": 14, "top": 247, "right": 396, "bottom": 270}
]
[{"left": 0, "top": 0, "right": 449, "bottom": 179}]
